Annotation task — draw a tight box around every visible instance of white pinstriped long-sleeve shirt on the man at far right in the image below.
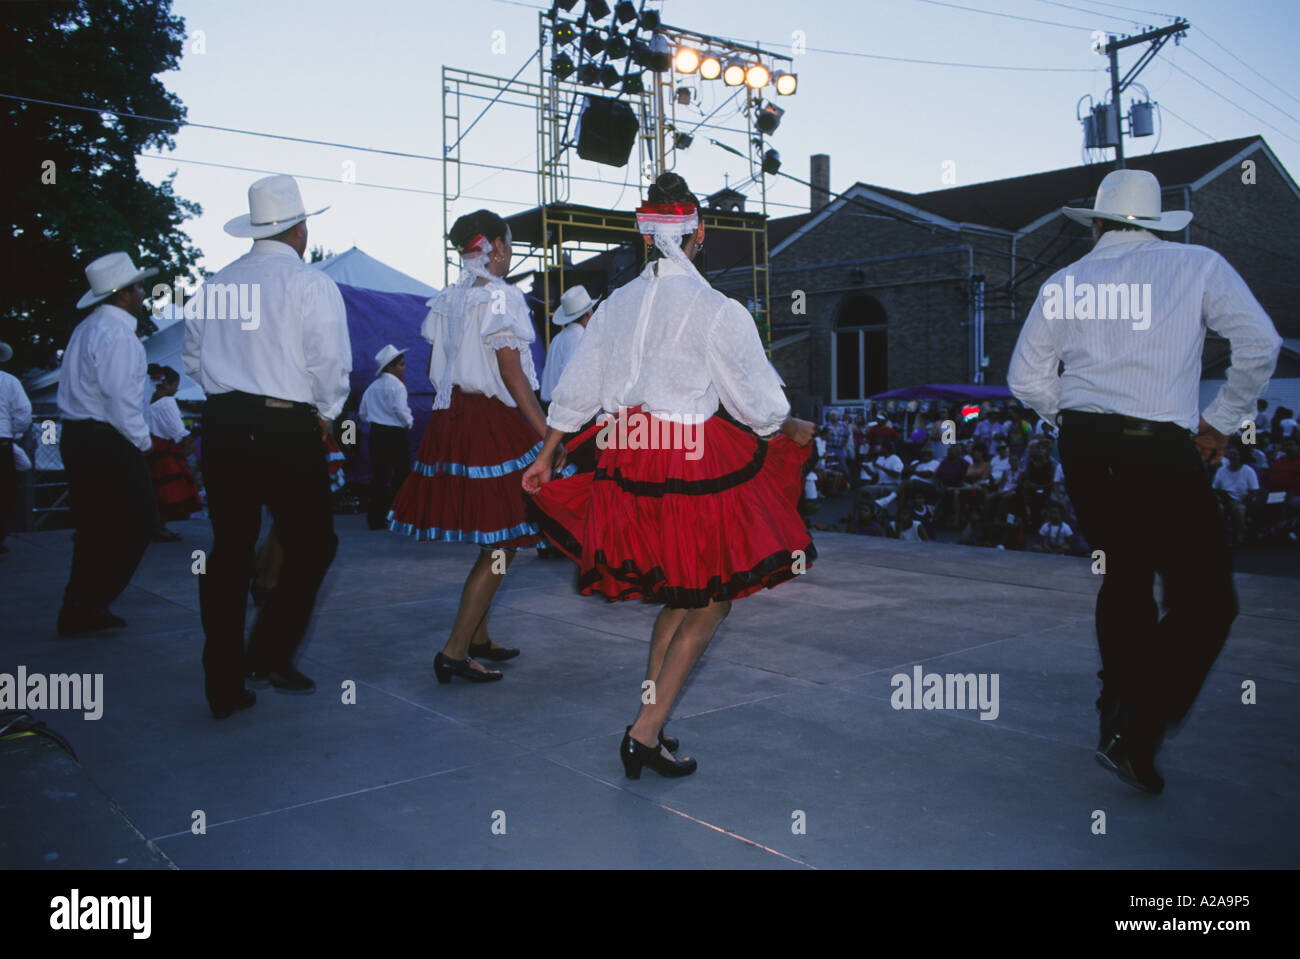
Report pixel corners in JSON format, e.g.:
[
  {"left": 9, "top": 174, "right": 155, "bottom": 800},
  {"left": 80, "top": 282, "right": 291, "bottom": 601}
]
[{"left": 1006, "top": 230, "right": 1282, "bottom": 433}]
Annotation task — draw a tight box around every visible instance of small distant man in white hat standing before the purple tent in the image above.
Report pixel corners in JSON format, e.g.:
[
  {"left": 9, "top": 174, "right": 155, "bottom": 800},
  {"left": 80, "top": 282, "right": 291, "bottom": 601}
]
[{"left": 360, "top": 343, "right": 415, "bottom": 529}]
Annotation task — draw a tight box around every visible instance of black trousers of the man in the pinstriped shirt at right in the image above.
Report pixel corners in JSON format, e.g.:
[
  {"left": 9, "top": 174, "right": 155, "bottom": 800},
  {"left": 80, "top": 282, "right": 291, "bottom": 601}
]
[{"left": 1058, "top": 411, "right": 1238, "bottom": 739}]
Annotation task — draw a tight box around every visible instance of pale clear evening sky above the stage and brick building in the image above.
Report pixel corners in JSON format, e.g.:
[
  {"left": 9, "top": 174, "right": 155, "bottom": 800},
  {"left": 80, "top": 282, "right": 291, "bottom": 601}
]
[{"left": 137, "top": 0, "right": 1300, "bottom": 287}]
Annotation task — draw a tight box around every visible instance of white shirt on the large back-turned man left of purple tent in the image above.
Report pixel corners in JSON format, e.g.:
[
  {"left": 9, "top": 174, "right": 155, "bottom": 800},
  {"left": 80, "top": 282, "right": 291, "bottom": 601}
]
[{"left": 185, "top": 239, "right": 352, "bottom": 420}]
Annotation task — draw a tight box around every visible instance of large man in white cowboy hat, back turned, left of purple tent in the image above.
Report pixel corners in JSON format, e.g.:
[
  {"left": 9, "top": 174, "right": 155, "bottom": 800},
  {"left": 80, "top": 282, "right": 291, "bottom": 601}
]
[{"left": 185, "top": 175, "right": 352, "bottom": 719}]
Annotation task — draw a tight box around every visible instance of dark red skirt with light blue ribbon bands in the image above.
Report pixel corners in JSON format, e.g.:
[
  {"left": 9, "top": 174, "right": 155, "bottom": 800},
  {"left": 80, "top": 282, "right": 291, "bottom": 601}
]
[{"left": 389, "top": 387, "right": 542, "bottom": 550}]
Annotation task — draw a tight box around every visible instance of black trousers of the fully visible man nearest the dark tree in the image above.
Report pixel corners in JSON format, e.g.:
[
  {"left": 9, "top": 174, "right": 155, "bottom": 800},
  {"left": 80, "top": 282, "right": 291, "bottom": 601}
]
[{"left": 59, "top": 420, "right": 153, "bottom": 609}]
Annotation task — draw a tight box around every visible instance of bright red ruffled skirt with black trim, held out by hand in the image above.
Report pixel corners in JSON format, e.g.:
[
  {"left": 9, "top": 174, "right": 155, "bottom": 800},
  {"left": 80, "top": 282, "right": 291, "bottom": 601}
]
[{"left": 533, "top": 409, "right": 816, "bottom": 609}]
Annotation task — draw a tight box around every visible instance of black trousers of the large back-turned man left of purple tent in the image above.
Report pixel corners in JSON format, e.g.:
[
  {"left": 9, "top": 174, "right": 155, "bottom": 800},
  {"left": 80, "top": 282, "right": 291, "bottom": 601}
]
[{"left": 199, "top": 392, "right": 338, "bottom": 708}]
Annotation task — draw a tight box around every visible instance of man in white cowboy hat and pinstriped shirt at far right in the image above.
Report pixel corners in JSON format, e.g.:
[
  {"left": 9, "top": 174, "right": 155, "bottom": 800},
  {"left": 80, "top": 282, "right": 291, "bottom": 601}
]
[{"left": 1006, "top": 170, "right": 1281, "bottom": 793}]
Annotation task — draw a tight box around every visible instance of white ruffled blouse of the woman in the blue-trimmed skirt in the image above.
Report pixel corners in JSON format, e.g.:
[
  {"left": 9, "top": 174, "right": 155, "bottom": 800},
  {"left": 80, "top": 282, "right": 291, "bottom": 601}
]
[{"left": 421, "top": 283, "right": 537, "bottom": 409}]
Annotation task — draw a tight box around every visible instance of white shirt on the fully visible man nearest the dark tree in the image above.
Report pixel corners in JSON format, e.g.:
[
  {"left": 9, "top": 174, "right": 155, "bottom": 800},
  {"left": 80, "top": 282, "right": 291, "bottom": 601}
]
[{"left": 57, "top": 303, "right": 152, "bottom": 450}]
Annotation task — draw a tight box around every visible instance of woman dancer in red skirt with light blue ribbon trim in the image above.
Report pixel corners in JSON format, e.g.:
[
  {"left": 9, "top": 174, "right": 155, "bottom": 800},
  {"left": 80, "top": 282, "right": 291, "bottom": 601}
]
[{"left": 389, "top": 209, "right": 546, "bottom": 682}]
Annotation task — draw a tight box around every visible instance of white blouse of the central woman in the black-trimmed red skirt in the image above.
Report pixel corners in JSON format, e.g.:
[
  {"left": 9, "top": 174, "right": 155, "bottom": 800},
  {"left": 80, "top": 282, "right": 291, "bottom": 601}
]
[{"left": 546, "top": 259, "right": 790, "bottom": 437}]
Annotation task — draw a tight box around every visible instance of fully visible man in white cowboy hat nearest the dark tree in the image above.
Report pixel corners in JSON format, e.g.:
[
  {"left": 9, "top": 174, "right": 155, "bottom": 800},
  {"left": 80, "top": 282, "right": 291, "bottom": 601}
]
[{"left": 59, "top": 252, "right": 157, "bottom": 635}]
